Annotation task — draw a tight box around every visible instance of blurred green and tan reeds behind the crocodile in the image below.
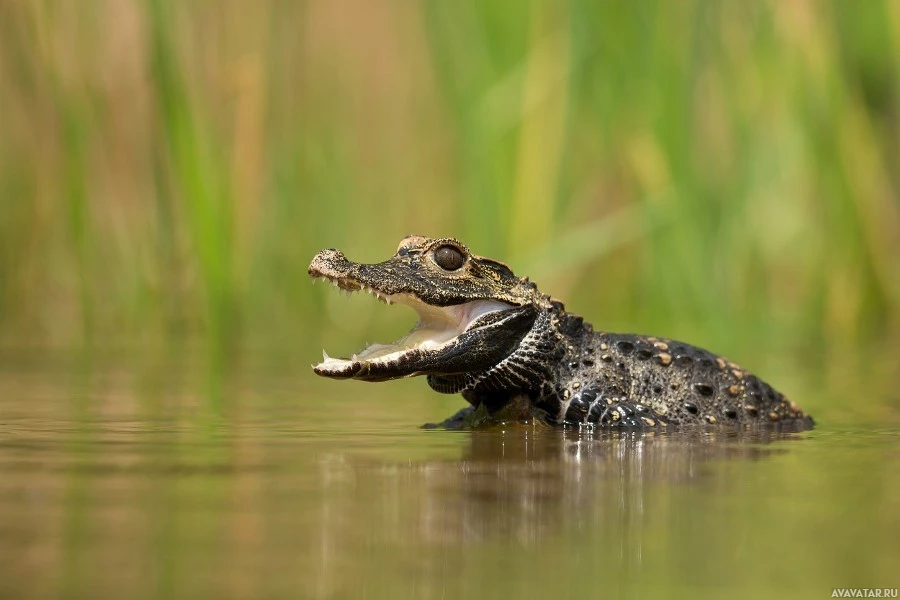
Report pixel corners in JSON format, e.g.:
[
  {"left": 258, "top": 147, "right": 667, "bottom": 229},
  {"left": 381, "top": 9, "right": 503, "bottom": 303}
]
[{"left": 0, "top": 0, "right": 900, "bottom": 408}]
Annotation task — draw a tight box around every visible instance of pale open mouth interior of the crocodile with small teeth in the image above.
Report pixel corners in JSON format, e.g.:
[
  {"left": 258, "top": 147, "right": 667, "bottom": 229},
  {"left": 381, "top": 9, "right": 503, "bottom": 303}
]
[{"left": 310, "top": 271, "right": 515, "bottom": 378}]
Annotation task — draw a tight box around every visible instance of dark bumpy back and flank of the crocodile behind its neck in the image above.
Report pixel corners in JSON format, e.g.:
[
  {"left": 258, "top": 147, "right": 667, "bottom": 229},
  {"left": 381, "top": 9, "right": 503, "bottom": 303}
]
[{"left": 538, "top": 324, "right": 812, "bottom": 428}]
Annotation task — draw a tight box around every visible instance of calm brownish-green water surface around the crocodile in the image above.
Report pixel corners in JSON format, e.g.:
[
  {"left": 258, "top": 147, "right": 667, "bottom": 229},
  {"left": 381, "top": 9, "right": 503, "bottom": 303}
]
[{"left": 0, "top": 352, "right": 900, "bottom": 598}]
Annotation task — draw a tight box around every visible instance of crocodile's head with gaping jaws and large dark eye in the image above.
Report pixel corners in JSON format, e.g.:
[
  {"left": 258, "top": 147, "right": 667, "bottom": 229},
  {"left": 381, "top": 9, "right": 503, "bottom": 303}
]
[{"left": 309, "top": 236, "right": 549, "bottom": 384}]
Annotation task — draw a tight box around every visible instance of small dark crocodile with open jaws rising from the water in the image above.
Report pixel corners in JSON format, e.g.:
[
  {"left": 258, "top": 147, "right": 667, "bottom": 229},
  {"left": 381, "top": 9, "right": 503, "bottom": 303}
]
[{"left": 308, "top": 235, "right": 813, "bottom": 430}]
